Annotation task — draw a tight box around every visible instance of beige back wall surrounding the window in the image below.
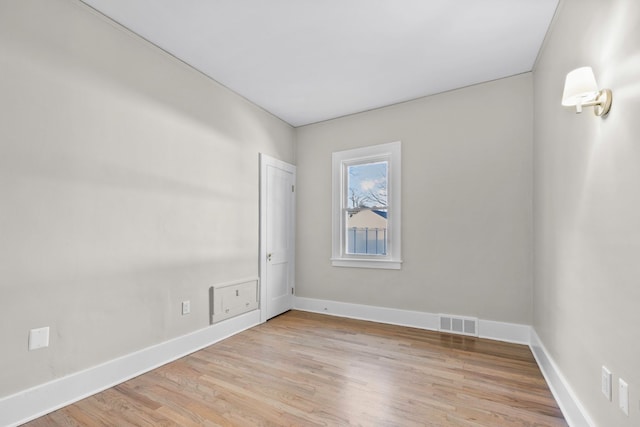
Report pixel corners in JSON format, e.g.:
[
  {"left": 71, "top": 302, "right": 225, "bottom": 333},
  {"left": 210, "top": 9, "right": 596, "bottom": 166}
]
[{"left": 296, "top": 74, "right": 533, "bottom": 324}]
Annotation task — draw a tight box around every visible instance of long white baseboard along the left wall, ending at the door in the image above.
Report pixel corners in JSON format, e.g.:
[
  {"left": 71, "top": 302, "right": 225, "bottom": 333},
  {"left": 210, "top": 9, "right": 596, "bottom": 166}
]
[{"left": 0, "top": 310, "right": 260, "bottom": 426}]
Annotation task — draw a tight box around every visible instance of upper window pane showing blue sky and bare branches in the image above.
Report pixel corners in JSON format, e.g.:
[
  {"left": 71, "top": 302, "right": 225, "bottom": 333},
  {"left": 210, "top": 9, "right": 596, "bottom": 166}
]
[{"left": 346, "top": 161, "right": 389, "bottom": 209}]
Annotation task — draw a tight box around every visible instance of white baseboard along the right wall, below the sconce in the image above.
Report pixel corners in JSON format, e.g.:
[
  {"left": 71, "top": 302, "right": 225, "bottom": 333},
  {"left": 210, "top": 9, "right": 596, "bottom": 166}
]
[{"left": 529, "top": 329, "right": 596, "bottom": 427}]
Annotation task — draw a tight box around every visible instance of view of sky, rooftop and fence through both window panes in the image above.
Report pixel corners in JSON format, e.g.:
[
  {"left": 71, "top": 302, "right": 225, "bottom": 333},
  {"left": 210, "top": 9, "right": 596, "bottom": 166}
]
[{"left": 345, "top": 161, "right": 389, "bottom": 255}]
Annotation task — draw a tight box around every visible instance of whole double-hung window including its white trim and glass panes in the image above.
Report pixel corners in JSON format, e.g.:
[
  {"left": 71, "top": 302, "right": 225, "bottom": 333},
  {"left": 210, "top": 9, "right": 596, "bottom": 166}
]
[{"left": 331, "top": 142, "right": 402, "bottom": 269}]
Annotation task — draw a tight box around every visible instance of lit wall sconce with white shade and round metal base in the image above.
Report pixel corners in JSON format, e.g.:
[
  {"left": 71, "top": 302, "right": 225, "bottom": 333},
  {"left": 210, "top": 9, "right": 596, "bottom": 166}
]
[{"left": 562, "top": 67, "right": 611, "bottom": 116}]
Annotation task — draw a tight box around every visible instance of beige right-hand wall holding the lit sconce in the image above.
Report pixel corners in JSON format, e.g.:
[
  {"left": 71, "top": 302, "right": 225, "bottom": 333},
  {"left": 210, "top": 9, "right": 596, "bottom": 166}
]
[{"left": 534, "top": 0, "right": 640, "bottom": 426}]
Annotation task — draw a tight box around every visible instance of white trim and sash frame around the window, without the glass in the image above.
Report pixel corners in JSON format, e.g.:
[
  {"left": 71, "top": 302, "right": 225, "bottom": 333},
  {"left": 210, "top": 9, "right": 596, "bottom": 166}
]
[{"left": 331, "top": 141, "right": 402, "bottom": 270}]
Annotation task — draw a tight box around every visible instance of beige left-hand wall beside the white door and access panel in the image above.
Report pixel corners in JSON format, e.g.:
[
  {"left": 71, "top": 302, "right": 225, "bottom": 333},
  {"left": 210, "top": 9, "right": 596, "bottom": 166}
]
[{"left": 0, "top": 0, "right": 294, "bottom": 397}]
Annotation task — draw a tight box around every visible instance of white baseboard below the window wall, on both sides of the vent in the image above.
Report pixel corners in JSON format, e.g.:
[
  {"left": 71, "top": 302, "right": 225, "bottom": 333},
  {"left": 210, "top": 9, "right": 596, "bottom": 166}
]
[{"left": 294, "top": 297, "right": 531, "bottom": 345}]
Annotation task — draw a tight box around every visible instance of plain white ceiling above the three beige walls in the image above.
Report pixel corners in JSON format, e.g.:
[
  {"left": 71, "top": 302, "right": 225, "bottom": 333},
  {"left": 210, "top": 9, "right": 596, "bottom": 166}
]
[{"left": 83, "top": 0, "right": 558, "bottom": 126}]
